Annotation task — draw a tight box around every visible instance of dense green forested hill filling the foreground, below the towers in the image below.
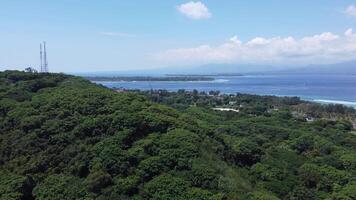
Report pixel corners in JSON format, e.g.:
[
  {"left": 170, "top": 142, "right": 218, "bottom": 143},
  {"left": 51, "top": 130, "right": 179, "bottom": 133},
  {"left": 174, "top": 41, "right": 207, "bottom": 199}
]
[{"left": 0, "top": 71, "right": 356, "bottom": 200}]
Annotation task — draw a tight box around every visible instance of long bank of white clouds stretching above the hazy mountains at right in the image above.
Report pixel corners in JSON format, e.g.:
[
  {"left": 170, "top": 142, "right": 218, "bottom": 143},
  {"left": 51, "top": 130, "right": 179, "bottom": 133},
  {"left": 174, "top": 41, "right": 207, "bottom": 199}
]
[{"left": 153, "top": 29, "right": 356, "bottom": 64}]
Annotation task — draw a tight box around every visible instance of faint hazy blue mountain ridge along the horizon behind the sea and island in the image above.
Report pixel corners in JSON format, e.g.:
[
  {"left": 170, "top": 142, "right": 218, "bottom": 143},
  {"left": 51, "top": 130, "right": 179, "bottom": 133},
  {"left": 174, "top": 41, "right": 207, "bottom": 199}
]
[{"left": 70, "top": 60, "right": 356, "bottom": 76}]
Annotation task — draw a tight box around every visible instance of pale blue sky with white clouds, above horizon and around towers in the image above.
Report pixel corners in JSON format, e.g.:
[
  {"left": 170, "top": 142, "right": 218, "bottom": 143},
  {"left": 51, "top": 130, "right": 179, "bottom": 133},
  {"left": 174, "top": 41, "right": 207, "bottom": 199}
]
[{"left": 0, "top": 0, "right": 356, "bottom": 72}]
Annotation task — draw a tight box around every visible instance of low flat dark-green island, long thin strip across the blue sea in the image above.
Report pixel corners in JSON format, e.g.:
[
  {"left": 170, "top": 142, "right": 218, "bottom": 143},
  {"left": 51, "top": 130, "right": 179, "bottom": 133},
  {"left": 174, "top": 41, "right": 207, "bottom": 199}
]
[{"left": 84, "top": 76, "right": 215, "bottom": 82}]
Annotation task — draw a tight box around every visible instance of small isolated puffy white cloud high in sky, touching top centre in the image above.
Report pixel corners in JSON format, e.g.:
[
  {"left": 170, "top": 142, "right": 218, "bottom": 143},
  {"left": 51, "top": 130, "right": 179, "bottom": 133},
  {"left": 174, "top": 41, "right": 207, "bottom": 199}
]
[{"left": 177, "top": 1, "right": 211, "bottom": 19}]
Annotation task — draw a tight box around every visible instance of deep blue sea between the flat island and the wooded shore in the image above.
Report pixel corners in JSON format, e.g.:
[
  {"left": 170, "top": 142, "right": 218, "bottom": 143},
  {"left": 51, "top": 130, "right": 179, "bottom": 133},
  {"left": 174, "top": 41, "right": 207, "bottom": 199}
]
[{"left": 97, "top": 75, "right": 356, "bottom": 107}]
